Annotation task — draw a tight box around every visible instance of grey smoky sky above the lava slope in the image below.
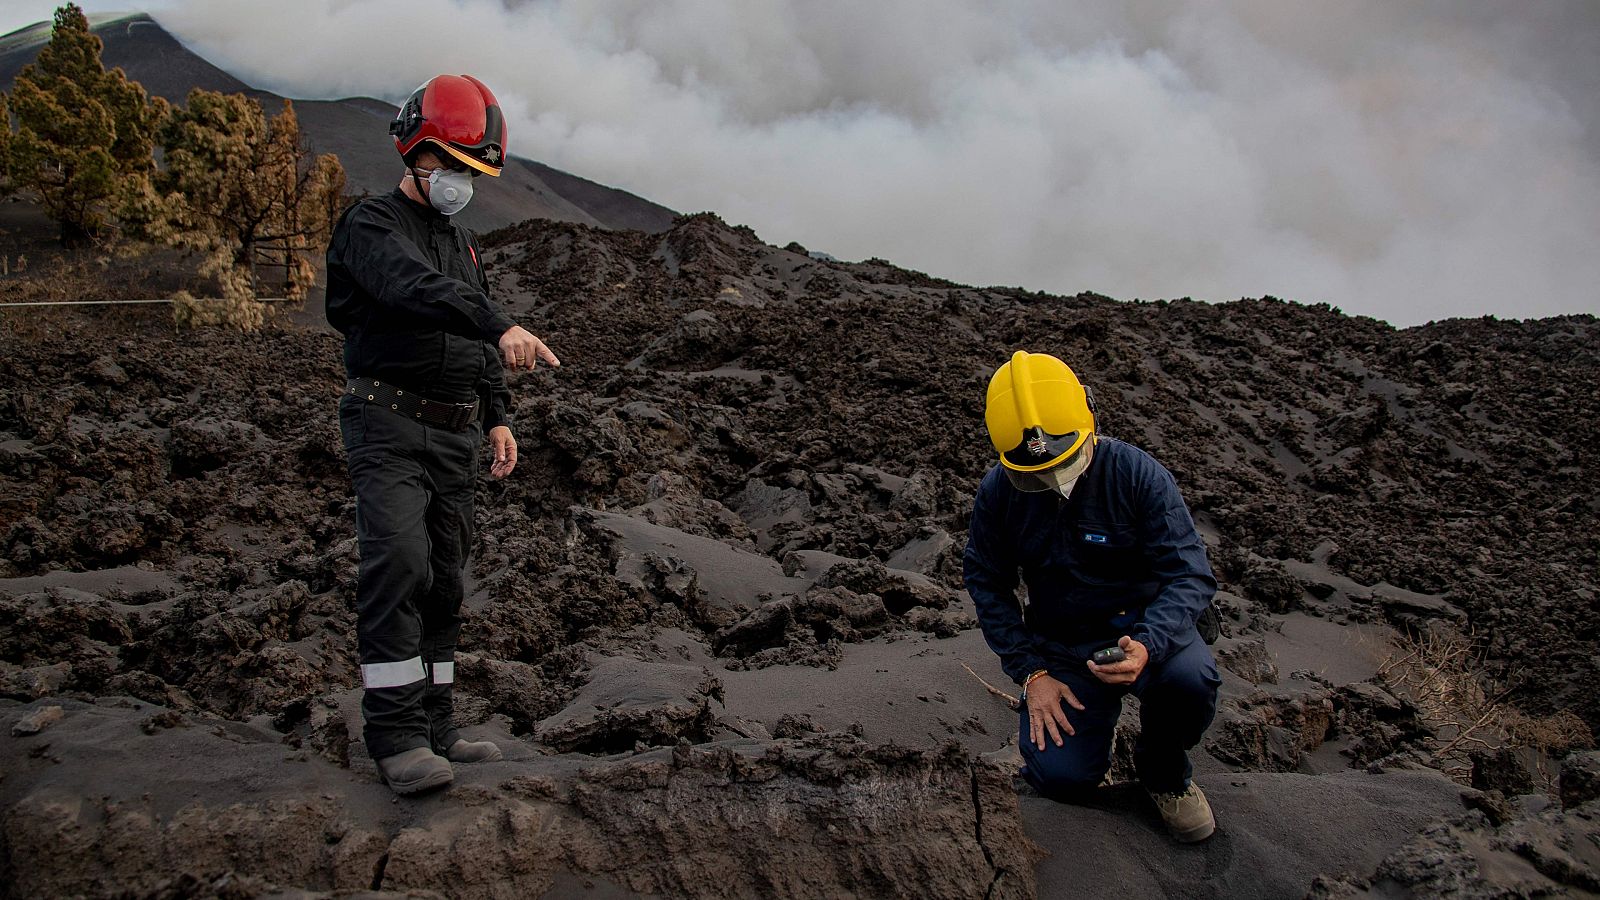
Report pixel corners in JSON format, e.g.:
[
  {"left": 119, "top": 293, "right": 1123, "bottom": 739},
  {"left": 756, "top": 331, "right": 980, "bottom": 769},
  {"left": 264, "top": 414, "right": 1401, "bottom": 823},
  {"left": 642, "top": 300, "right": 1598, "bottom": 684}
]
[{"left": 0, "top": 0, "right": 1600, "bottom": 325}]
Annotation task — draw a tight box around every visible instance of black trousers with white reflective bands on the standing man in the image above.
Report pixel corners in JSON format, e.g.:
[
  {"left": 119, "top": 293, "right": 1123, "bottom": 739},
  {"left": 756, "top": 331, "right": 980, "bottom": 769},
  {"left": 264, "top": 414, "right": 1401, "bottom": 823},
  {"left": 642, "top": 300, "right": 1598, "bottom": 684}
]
[{"left": 339, "top": 394, "right": 483, "bottom": 759}]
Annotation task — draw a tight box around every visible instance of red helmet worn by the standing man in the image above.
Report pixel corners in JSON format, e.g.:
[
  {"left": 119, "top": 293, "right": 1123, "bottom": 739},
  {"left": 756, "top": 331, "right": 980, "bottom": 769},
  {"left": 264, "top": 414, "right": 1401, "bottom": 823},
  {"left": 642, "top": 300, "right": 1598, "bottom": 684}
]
[{"left": 389, "top": 75, "right": 506, "bottom": 175}]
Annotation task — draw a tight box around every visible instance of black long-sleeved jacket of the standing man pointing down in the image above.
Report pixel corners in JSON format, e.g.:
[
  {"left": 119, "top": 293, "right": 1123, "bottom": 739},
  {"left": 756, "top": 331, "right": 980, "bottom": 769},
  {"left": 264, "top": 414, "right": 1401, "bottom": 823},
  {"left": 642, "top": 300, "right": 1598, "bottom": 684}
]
[{"left": 328, "top": 187, "right": 514, "bottom": 431}]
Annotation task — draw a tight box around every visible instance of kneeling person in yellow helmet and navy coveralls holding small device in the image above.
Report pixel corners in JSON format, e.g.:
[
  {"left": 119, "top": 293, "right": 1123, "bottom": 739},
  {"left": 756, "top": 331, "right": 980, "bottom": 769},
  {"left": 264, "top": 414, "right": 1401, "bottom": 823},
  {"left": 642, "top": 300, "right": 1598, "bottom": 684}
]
[{"left": 965, "top": 351, "right": 1221, "bottom": 842}]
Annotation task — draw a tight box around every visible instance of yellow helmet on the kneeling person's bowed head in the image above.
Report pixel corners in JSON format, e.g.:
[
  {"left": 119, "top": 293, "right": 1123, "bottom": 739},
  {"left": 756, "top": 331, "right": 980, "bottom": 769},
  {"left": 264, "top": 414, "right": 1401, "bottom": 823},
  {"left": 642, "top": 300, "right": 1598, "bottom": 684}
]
[{"left": 984, "top": 351, "right": 1094, "bottom": 490}]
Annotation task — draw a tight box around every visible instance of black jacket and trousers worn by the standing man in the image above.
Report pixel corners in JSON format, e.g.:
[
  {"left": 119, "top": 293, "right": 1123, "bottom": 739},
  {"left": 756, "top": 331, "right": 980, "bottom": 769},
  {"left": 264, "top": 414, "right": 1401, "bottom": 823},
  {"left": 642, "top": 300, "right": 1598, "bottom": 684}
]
[{"left": 328, "top": 189, "right": 512, "bottom": 759}]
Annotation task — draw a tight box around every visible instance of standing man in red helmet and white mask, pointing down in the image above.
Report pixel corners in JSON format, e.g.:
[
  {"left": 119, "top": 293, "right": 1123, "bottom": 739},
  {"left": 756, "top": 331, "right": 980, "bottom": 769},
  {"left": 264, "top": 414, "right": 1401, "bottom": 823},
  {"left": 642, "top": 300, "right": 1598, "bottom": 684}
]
[{"left": 328, "top": 75, "right": 560, "bottom": 794}]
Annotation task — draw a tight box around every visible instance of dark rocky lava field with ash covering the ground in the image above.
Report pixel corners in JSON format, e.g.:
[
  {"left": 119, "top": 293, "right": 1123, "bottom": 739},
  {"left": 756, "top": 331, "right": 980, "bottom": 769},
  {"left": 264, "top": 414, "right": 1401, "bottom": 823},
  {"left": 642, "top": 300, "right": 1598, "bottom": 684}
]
[{"left": 0, "top": 215, "right": 1600, "bottom": 897}]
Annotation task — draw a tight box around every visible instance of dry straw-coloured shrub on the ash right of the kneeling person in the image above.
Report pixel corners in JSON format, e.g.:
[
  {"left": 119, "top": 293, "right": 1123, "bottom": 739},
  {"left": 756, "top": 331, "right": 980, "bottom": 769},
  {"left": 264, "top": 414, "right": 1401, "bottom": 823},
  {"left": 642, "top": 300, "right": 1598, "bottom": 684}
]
[{"left": 1378, "top": 626, "right": 1594, "bottom": 790}]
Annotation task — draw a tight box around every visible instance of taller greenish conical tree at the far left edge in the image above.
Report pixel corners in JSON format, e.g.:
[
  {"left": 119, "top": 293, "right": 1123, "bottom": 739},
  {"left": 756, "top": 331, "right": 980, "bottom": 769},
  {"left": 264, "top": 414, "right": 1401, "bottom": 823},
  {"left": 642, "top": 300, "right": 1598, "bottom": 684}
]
[{"left": 8, "top": 3, "right": 166, "bottom": 245}]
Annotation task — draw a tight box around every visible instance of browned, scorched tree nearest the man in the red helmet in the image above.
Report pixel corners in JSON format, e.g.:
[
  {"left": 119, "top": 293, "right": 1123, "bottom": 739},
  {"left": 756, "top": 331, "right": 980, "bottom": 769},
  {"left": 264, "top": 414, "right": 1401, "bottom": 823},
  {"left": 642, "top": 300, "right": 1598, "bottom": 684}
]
[{"left": 125, "top": 88, "right": 344, "bottom": 330}]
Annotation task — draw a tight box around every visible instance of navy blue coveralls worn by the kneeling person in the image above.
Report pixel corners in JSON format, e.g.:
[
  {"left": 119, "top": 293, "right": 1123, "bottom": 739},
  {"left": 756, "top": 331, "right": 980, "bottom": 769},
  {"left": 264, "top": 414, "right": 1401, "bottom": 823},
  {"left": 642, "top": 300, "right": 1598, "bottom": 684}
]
[{"left": 965, "top": 437, "right": 1221, "bottom": 798}]
